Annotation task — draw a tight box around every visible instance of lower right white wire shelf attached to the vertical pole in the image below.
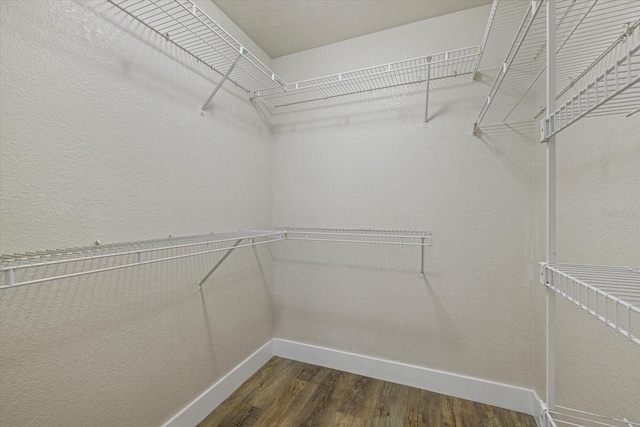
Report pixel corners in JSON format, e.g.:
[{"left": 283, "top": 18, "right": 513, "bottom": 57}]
[{"left": 540, "top": 263, "right": 640, "bottom": 345}]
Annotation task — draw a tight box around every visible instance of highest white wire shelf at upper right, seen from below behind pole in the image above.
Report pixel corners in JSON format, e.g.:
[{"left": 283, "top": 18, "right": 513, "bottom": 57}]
[{"left": 475, "top": 0, "right": 640, "bottom": 128}]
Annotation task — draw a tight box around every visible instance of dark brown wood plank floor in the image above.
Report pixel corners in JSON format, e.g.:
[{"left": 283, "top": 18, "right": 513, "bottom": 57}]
[{"left": 199, "top": 357, "right": 536, "bottom": 427}]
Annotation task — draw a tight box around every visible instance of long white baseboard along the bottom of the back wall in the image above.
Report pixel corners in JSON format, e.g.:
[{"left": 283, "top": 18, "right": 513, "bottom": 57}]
[{"left": 274, "top": 339, "right": 540, "bottom": 416}]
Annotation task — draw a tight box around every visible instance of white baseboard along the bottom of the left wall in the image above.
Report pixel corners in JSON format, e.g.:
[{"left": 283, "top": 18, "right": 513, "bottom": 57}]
[{"left": 164, "top": 340, "right": 273, "bottom": 427}]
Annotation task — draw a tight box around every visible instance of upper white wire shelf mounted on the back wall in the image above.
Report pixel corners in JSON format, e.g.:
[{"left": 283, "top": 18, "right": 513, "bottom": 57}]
[{"left": 253, "top": 46, "right": 480, "bottom": 108}]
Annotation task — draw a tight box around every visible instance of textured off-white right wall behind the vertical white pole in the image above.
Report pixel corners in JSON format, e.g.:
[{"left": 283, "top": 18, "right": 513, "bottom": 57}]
[{"left": 534, "top": 116, "right": 640, "bottom": 422}]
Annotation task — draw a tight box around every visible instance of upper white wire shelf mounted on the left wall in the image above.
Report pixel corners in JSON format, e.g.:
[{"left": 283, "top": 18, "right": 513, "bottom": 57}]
[{"left": 109, "top": 0, "right": 285, "bottom": 92}]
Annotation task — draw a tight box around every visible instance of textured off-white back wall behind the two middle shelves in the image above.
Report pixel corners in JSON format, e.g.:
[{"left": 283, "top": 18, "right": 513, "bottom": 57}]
[{"left": 273, "top": 7, "right": 534, "bottom": 388}]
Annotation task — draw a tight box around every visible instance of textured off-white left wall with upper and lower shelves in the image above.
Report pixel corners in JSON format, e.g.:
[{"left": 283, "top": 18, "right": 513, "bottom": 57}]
[{"left": 0, "top": 0, "right": 273, "bottom": 426}]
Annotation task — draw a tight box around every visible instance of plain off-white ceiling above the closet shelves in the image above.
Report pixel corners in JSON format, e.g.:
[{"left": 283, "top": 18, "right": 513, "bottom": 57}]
[{"left": 212, "top": 0, "right": 491, "bottom": 58}]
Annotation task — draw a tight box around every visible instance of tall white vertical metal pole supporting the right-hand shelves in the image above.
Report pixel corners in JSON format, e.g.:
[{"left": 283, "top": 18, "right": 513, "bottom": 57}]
[{"left": 546, "top": 0, "right": 556, "bottom": 411}]
